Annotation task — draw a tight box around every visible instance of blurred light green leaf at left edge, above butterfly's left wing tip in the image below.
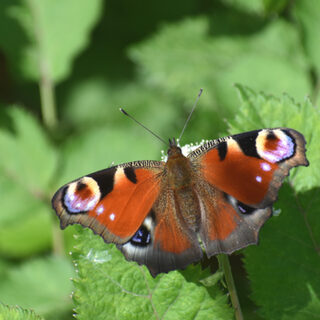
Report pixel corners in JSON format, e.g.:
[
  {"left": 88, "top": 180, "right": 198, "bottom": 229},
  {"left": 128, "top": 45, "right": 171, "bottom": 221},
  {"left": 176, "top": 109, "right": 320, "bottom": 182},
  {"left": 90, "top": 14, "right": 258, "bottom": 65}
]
[{"left": 0, "top": 107, "right": 57, "bottom": 192}]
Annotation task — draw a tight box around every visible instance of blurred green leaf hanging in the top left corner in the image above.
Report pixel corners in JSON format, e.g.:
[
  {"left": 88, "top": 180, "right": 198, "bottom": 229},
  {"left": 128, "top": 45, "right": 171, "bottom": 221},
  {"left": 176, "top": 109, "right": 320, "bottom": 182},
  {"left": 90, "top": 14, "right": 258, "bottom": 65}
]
[{"left": 0, "top": 0, "right": 102, "bottom": 82}]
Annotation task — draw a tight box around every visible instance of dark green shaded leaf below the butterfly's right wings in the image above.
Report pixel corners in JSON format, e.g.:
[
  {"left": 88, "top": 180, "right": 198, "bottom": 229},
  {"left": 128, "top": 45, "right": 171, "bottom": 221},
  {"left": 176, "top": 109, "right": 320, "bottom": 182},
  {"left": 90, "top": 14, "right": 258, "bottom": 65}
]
[{"left": 244, "top": 185, "right": 320, "bottom": 320}]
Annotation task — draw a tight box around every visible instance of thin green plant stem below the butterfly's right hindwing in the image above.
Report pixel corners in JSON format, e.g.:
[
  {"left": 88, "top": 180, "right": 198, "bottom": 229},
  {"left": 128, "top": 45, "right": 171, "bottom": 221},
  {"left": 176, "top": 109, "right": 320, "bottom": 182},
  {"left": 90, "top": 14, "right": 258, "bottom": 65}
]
[{"left": 218, "top": 254, "right": 243, "bottom": 320}]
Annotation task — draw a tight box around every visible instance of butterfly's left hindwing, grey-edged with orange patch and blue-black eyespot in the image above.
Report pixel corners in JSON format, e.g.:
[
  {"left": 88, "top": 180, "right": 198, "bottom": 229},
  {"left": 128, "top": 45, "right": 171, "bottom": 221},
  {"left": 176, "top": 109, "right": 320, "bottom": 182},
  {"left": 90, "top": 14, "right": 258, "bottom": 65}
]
[{"left": 118, "top": 188, "right": 203, "bottom": 276}]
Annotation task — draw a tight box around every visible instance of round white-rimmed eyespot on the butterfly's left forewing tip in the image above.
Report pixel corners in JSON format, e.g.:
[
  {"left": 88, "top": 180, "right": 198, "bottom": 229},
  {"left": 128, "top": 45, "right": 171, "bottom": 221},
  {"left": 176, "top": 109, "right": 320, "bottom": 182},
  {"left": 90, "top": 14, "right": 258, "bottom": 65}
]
[{"left": 63, "top": 177, "right": 103, "bottom": 213}]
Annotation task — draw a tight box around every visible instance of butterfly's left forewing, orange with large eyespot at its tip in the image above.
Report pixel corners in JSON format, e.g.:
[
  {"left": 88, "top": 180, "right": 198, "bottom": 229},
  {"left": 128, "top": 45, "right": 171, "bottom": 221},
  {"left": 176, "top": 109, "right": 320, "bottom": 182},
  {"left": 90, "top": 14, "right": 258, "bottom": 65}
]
[{"left": 52, "top": 161, "right": 163, "bottom": 243}]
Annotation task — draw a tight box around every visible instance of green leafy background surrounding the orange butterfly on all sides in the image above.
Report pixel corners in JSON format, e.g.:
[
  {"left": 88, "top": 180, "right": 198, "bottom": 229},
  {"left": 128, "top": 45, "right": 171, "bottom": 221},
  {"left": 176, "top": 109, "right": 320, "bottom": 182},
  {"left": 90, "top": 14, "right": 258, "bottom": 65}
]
[{"left": 0, "top": 0, "right": 320, "bottom": 320}]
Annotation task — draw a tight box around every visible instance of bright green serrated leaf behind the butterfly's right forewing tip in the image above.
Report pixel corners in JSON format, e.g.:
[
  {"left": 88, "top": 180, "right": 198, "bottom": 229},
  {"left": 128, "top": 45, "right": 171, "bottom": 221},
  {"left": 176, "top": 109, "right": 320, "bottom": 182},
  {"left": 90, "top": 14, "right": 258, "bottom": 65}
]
[{"left": 229, "top": 85, "right": 320, "bottom": 191}]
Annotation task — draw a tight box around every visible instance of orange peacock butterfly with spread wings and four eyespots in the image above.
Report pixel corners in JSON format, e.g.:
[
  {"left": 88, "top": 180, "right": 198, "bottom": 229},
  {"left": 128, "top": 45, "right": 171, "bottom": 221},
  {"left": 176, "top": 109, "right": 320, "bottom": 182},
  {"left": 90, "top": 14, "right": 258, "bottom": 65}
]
[{"left": 52, "top": 128, "right": 309, "bottom": 277}]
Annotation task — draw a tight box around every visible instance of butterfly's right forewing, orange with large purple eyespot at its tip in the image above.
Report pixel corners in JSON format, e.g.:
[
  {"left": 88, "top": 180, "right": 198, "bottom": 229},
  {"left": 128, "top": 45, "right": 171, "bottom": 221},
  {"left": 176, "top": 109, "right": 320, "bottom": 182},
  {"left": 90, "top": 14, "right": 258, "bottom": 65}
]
[{"left": 189, "top": 128, "right": 308, "bottom": 208}]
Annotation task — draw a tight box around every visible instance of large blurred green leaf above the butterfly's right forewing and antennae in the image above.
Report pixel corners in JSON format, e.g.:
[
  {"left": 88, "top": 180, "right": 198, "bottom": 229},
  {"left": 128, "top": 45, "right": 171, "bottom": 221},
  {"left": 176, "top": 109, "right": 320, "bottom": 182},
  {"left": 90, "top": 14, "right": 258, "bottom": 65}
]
[{"left": 129, "top": 17, "right": 312, "bottom": 121}]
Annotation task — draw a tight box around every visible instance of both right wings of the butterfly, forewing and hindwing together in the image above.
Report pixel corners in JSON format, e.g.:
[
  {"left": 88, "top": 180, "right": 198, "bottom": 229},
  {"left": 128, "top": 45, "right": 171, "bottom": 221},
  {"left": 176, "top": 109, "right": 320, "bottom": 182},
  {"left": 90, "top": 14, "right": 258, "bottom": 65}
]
[{"left": 189, "top": 128, "right": 308, "bottom": 256}]
